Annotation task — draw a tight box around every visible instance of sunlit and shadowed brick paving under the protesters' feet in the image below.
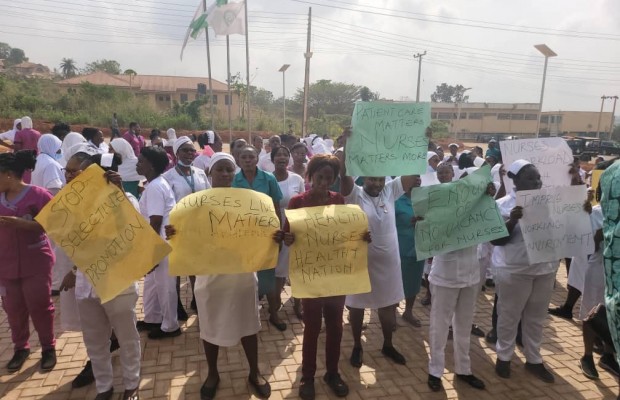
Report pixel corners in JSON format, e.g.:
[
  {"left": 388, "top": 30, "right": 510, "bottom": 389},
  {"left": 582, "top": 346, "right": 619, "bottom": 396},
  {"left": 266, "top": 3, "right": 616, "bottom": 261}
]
[{"left": 0, "top": 267, "right": 618, "bottom": 400}]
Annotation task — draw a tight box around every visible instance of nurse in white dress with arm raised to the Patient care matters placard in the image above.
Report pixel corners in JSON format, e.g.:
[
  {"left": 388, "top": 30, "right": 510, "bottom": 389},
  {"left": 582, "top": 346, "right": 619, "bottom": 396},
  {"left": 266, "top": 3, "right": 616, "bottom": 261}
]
[{"left": 340, "top": 131, "right": 418, "bottom": 368}]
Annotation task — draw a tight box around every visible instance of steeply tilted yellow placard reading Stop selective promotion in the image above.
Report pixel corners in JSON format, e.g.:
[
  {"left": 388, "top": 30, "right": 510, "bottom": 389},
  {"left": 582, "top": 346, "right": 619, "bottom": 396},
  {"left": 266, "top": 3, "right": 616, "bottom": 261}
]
[{"left": 35, "top": 165, "right": 171, "bottom": 303}]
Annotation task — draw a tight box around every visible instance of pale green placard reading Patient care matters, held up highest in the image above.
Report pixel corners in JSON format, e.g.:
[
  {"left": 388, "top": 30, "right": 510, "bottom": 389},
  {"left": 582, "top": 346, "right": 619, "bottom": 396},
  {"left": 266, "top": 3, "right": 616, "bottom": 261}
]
[{"left": 345, "top": 101, "right": 431, "bottom": 176}]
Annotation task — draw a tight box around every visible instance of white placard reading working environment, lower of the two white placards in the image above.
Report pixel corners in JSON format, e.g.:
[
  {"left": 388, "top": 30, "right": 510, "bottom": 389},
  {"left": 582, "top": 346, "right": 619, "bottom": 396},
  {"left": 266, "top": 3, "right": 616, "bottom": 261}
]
[{"left": 516, "top": 185, "right": 594, "bottom": 264}]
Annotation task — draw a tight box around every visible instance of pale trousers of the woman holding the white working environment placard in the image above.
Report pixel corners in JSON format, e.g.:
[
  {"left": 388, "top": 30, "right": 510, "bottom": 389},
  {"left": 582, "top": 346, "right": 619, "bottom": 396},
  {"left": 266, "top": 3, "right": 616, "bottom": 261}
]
[{"left": 495, "top": 268, "right": 555, "bottom": 364}]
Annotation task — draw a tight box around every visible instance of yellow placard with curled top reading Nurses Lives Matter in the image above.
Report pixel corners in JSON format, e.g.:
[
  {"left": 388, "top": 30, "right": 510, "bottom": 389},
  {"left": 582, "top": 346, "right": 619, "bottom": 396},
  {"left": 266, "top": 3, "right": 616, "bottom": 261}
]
[{"left": 170, "top": 188, "right": 280, "bottom": 275}]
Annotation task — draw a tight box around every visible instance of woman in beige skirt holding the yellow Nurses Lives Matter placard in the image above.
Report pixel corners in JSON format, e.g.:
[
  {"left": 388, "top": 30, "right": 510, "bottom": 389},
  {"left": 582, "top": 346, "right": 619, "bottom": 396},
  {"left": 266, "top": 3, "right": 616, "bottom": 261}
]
[{"left": 166, "top": 152, "right": 271, "bottom": 400}]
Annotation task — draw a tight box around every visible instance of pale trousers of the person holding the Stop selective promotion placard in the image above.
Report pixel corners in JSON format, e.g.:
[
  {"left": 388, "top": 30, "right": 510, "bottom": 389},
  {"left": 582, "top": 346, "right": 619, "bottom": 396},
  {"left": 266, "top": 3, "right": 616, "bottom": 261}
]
[{"left": 78, "top": 292, "right": 141, "bottom": 393}]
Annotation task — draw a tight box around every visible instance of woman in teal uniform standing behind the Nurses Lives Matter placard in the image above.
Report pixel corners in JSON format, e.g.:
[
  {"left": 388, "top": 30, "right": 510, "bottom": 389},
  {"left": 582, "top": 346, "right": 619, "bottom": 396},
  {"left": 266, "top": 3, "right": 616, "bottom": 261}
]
[{"left": 232, "top": 146, "right": 286, "bottom": 331}]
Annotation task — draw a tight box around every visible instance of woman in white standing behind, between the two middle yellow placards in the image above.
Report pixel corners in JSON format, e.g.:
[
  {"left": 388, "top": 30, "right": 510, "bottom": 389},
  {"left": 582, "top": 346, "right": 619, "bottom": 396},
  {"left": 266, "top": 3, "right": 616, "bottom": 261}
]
[{"left": 270, "top": 145, "right": 306, "bottom": 320}]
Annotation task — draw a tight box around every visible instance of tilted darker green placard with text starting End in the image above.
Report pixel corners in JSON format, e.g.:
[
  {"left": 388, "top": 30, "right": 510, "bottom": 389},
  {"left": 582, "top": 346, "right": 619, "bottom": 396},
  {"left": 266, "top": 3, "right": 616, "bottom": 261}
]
[{"left": 411, "top": 165, "right": 508, "bottom": 260}]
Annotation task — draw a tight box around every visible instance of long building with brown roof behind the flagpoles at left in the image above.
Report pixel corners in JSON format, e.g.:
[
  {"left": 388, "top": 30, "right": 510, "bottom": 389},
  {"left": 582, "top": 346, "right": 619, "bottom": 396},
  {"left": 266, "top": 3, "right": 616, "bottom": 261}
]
[{"left": 58, "top": 71, "right": 240, "bottom": 119}]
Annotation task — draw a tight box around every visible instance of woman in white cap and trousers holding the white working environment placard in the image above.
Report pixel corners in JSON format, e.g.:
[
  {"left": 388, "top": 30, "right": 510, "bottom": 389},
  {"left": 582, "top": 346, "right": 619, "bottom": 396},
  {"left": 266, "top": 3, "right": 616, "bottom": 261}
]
[{"left": 491, "top": 160, "right": 559, "bottom": 383}]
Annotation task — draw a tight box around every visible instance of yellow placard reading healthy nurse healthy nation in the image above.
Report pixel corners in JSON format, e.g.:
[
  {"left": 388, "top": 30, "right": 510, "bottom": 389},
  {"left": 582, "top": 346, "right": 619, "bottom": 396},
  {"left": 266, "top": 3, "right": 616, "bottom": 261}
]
[{"left": 285, "top": 205, "right": 370, "bottom": 298}]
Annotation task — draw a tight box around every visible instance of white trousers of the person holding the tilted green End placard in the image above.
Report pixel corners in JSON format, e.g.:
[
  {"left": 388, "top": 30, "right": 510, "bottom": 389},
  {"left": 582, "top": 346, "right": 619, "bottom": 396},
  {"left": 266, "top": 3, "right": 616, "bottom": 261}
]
[{"left": 428, "top": 284, "right": 480, "bottom": 378}]
